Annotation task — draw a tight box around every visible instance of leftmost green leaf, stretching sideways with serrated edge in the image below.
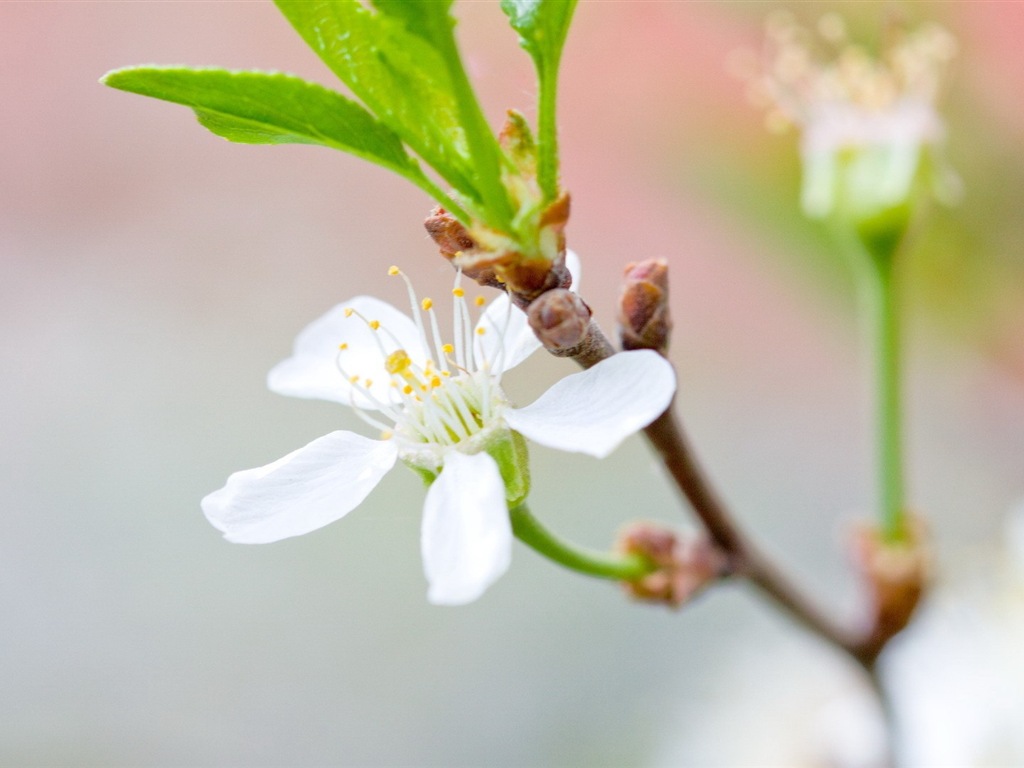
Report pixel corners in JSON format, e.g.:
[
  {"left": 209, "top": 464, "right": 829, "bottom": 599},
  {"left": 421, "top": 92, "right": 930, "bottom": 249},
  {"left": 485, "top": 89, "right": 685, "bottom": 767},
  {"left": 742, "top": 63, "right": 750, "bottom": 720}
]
[{"left": 100, "top": 67, "right": 422, "bottom": 177}]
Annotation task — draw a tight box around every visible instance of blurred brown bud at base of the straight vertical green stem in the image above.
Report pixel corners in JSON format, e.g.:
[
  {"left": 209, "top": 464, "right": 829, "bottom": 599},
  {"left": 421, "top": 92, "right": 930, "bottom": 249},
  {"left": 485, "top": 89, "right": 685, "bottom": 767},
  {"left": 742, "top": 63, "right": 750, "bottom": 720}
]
[{"left": 851, "top": 522, "right": 931, "bottom": 649}]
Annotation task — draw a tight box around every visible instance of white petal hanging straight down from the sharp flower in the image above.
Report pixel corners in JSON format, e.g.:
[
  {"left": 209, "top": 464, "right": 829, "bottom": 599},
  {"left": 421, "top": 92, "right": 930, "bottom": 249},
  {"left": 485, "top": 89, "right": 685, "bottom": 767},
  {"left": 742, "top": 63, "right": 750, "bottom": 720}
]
[{"left": 422, "top": 451, "right": 512, "bottom": 605}]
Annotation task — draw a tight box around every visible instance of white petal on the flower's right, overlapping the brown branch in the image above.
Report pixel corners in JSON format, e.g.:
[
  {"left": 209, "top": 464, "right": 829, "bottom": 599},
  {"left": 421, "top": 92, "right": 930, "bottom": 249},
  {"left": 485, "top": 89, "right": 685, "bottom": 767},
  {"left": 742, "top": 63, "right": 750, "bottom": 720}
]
[{"left": 505, "top": 349, "right": 676, "bottom": 458}]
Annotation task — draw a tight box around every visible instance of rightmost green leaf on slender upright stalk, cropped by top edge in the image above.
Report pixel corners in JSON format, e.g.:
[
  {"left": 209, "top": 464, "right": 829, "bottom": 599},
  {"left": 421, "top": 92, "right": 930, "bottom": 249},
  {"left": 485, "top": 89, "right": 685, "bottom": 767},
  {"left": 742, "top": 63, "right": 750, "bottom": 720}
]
[{"left": 502, "top": 0, "right": 577, "bottom": 202}]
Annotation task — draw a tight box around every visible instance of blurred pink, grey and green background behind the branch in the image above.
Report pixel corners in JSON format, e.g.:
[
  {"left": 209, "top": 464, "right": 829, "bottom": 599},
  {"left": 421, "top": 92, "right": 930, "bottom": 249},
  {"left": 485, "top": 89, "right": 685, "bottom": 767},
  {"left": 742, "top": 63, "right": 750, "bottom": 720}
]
[{"left": 6, "top": 0, "right": 1024, "bottom": 766}]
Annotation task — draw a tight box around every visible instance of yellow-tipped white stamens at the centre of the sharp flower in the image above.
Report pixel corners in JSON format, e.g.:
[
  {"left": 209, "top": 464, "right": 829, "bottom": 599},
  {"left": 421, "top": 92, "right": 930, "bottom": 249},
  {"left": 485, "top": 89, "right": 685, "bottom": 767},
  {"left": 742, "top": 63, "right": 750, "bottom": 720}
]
[{"left": 337, "top": 266, "right": 505, "bottom": 468}]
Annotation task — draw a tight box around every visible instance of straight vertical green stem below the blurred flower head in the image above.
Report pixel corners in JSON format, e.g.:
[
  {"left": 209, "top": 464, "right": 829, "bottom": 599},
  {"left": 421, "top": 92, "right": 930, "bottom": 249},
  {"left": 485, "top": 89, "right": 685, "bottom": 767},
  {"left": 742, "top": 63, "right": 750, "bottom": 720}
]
[{"left": 863, "top": 257, "right": 905, "bottom": 543}]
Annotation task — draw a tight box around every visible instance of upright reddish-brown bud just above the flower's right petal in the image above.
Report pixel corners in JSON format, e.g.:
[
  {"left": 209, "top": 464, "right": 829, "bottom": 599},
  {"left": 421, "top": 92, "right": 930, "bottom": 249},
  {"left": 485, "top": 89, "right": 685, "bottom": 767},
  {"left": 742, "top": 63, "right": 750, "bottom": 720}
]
[{"left": 618, "top": 259, "right": 672, "bottom": 354}]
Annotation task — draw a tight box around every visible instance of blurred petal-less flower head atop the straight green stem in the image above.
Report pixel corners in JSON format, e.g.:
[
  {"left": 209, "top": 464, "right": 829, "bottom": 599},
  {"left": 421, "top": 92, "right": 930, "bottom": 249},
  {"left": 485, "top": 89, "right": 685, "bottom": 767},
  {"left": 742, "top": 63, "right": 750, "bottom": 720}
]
[{"left": 751, "top": 14, "right": 957, "bottom": 220}]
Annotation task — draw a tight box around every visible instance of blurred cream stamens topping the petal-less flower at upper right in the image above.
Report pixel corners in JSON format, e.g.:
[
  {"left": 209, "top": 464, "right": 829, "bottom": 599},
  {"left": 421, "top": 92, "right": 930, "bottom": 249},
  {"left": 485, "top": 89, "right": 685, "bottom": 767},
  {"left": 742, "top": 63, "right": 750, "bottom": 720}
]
[{"left": 736, "top": 12, "right": 956, "bottom": 134}]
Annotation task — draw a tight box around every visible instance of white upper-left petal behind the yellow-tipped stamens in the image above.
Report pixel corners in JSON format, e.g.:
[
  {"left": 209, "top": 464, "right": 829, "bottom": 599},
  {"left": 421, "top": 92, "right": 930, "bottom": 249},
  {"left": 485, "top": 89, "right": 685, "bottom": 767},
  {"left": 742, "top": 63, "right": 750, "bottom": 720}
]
[{"left": 267, "top": 296, "right": 426, "bottom": 409}]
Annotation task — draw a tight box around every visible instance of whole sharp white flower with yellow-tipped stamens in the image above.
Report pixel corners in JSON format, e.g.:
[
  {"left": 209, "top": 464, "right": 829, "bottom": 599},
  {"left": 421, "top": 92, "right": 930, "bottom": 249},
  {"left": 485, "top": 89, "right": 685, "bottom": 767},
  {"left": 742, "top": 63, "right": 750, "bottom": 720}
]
[{"left": 203, "top": 259, "right": 675, "bottom": 604}]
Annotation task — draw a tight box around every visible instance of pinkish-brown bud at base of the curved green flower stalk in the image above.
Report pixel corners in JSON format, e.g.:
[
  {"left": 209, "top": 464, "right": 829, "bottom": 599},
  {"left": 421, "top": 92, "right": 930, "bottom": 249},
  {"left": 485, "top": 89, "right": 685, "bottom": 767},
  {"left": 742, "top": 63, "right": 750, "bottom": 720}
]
[{"left": 618, "top": 522, "right": 727, "bottom": 608}]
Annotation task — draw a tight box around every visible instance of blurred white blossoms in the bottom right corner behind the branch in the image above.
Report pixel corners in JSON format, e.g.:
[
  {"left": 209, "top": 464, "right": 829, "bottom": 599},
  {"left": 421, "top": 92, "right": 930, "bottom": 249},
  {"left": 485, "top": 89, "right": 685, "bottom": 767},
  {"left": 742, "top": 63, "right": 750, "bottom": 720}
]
[{"left": 654, "top": 503, "right": 1024, "bottom": 768}]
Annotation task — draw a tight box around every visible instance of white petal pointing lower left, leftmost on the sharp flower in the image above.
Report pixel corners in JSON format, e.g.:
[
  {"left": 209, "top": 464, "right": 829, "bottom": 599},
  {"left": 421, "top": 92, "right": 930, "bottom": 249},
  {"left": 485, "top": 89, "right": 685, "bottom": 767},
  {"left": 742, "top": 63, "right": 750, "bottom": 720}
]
[{"left": 203, "top": 432, "right": 398, "bottom": 544}]
